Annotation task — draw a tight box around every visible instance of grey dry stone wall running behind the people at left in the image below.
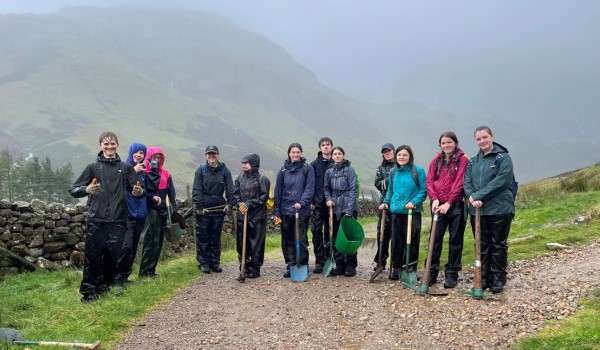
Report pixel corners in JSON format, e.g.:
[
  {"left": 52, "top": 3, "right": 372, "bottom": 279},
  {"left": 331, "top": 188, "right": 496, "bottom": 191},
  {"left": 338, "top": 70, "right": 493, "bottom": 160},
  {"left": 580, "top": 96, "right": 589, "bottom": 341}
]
[{"left": 0, "top": 199, "right": 377, "bottom": 275}]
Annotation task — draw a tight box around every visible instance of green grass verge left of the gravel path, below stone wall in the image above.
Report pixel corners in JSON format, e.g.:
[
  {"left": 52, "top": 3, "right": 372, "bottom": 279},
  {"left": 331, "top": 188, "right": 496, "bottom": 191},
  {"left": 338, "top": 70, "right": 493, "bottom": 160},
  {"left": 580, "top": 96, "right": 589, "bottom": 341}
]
[{"left": 0, "top": 234, "right": 281, "bottom": 350}]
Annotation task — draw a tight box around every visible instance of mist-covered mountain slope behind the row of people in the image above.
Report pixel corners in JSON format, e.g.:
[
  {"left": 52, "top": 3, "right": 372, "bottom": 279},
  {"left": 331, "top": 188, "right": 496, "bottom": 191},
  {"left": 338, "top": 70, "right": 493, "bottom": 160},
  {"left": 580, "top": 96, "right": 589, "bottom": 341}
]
[{"left": 0, "top": 7, "right": 598, "bottom": 193}]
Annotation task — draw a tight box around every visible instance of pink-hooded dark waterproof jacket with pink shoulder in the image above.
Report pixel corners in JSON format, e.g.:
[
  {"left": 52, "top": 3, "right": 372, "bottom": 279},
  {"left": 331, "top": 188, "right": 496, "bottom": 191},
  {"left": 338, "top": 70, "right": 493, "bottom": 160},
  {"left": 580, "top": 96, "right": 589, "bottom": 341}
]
[{"left": 144, "top": 147, "right": 176, "bottom": 216}]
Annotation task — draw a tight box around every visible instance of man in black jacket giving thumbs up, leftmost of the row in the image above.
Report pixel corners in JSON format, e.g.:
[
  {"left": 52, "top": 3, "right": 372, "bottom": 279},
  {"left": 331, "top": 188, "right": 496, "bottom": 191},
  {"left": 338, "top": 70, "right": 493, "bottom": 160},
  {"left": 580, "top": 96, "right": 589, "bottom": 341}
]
[{"left": 69, "top": 131, "right": 146, "bottom": 302}]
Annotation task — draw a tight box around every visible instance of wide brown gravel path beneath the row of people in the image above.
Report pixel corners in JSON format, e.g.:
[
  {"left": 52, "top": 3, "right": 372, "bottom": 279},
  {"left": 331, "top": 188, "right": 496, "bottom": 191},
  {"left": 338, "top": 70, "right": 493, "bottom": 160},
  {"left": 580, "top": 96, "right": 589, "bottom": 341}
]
[{"left": 115, "top": 240, "right": 600, "bottom": 350}]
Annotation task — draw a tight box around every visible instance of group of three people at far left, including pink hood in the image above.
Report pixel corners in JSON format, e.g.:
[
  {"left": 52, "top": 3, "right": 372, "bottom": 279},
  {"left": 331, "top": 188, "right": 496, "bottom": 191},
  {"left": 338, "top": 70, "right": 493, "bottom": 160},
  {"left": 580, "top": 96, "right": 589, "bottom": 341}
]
[{"left": 69, "top": 132, "right": 176, "bottom": 302}]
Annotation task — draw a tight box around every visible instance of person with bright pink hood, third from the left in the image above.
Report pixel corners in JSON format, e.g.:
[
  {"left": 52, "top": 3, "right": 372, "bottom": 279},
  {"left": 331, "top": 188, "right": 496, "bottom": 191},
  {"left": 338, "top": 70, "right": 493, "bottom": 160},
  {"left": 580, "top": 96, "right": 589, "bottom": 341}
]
[{"left": 139, "top": 147, "right": 176, "bottom": 278}]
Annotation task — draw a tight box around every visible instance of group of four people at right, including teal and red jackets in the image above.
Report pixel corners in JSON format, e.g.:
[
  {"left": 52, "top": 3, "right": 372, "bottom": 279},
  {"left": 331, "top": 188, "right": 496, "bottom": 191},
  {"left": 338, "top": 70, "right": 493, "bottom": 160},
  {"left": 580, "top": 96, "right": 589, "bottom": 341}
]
[{"left": 375, "top": 126, "right": 515, "bottom": 293}]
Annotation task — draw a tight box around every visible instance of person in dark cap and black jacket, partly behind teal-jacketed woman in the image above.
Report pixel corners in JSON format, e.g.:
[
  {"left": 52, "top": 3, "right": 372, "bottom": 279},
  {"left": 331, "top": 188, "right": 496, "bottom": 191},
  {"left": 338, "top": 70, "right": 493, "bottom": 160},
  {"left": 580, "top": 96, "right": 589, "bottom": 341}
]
[{"left": 373, "top": 143, "right": 396, "bottom": 271}]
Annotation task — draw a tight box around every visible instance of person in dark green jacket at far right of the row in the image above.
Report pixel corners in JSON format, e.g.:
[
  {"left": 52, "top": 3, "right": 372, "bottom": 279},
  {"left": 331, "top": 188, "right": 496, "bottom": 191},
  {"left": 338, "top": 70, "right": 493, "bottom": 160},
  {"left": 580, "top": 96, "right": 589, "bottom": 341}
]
[{"left": 464, "top": 126, "right": 515, "bottom": 293}]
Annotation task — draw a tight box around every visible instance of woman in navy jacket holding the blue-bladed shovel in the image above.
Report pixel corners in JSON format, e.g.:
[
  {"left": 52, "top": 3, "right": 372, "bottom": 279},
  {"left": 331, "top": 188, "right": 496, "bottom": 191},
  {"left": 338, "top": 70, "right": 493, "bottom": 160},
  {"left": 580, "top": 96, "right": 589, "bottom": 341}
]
[{"left": 273, "top": 143, "right": 315, "bottom": 278}]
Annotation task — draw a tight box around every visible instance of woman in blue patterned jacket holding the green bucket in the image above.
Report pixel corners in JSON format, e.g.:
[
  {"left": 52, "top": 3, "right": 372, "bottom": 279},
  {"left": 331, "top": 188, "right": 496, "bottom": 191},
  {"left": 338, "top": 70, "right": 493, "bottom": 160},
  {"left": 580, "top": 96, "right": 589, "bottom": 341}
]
[{"left": 325, "top": 147, "right": 358, "bottom": 277}]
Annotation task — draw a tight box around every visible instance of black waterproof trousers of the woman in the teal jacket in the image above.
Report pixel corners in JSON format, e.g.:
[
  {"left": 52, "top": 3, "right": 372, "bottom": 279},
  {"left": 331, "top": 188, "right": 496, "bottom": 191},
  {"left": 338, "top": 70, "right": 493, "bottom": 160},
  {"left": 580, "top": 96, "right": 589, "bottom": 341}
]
[{"left": 392, "top": 213, "right": 421, "bottom": 271}]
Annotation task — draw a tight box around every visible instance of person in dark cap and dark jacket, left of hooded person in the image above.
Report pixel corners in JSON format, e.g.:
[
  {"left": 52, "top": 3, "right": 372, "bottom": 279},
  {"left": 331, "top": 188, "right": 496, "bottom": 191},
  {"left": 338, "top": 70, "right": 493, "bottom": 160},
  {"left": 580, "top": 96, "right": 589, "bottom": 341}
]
[{"left": 192, "top": 145, "right": 234, "bottom": 273}]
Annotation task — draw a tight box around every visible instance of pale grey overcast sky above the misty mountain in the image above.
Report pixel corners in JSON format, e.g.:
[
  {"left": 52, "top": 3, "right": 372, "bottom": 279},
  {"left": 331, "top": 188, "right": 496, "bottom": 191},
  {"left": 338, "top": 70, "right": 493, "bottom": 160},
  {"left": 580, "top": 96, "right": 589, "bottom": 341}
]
[{"left": 0, "top": 0, "right": 600, "bottom": 108}]
